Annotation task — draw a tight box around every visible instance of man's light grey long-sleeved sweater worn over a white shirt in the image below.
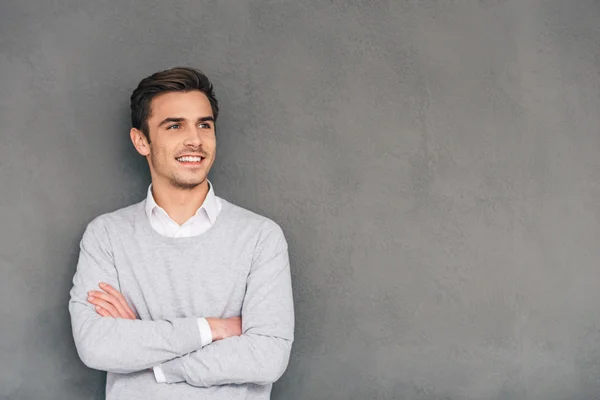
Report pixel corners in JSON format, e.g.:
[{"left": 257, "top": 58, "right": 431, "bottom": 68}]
[{"left": 69, "top": 199, "right": 294, "bottom": 400}]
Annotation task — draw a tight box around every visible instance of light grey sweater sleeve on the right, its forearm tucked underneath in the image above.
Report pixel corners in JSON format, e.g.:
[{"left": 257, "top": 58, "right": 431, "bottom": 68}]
[{"left": 157, "top": 220, "right": 294, "bottom": 387}]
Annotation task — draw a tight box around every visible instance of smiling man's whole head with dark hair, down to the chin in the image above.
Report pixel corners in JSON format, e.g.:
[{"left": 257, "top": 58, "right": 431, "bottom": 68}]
[{"left": 130, "top": 67, "right": 219, "bottom": 189}]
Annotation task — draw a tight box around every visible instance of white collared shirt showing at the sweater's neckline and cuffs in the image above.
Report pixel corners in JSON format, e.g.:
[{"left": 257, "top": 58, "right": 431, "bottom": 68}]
[{"left": 146, "top": 181, "right": 222, "bottom": 383}]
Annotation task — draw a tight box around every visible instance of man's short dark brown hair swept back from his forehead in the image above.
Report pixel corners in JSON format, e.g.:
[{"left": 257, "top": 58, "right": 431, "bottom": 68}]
[{"left": 130, "top": 67, "right": 219, "bottom": 141}]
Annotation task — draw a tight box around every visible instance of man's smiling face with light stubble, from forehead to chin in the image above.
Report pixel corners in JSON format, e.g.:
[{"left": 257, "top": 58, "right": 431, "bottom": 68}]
[{"left": 139, "top": 91, "right": 216, "bottom": 189}]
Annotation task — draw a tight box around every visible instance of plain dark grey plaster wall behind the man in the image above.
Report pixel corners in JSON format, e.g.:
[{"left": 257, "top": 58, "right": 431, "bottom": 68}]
[{"left": 0, "top": 0, "right": 600, "bottom": 400}]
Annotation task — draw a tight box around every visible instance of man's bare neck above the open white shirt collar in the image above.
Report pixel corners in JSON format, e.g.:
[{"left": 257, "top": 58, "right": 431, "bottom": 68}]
[{"left": 152, "top": 179, "right": 209, "bottom": 225}]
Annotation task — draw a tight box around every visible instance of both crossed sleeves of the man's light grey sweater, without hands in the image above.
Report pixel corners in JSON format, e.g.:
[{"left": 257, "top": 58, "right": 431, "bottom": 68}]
[{"left": 69, "top": 219, "right": 294, "bottom": 387}]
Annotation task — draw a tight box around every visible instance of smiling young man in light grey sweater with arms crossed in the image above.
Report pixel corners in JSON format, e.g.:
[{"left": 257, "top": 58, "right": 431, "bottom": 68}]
[{"left": 69, "top": 68, "right": 294, "bottom": 400}]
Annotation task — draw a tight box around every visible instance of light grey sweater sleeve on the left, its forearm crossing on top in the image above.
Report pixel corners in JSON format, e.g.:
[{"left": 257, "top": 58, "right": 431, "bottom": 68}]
[{"left": 69, "top": 218, "right": 202, "bottom": 373}]
